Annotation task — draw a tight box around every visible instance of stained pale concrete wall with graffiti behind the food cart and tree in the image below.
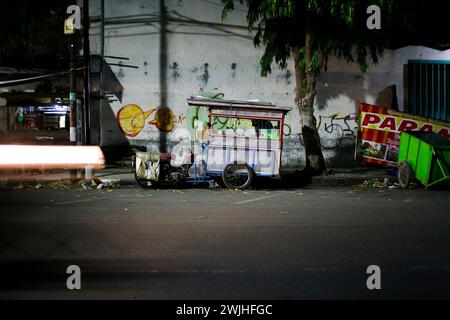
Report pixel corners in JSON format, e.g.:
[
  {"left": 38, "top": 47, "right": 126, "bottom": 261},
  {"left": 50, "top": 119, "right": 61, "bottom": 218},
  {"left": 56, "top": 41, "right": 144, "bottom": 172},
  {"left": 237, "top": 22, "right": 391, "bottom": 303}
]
[{"left": 85, "top": 0, "right": 450, "bottom": 167}]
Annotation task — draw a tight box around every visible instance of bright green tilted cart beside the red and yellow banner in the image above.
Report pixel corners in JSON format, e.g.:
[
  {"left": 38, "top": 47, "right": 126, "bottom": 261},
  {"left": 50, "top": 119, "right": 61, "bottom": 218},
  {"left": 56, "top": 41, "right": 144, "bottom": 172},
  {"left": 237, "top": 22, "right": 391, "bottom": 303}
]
[{"left": 398, "top": 132, "right": 450, "bottom": 189}]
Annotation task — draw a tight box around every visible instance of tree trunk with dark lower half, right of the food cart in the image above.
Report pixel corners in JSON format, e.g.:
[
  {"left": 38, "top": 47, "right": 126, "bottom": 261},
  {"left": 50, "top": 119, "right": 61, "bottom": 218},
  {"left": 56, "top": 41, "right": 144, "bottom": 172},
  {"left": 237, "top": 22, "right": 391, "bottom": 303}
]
[{"left": 294, "top": 22, "right": 326, "bottom": 177}]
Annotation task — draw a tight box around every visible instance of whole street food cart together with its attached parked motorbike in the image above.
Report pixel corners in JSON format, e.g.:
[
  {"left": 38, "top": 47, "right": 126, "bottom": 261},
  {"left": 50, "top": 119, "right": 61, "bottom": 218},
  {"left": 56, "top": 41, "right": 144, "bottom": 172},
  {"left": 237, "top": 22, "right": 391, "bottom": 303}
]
[{"left": 136, "top": 97, "right": 291, "bottom": 189}]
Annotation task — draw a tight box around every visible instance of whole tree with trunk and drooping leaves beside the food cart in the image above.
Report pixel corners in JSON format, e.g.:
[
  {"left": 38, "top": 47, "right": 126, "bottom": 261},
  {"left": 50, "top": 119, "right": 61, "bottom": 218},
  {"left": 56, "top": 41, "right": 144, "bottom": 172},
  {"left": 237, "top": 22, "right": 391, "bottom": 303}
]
[{"left": 222, "top": 0, "right": 412, "bottom": 177}]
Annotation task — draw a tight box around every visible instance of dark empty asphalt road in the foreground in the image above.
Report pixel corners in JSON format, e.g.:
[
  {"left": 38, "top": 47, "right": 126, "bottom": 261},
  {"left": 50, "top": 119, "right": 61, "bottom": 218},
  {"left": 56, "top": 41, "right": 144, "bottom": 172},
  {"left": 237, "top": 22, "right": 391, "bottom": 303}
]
[{"left": 0, "top": 187, "right": 450, "bottom": 299}]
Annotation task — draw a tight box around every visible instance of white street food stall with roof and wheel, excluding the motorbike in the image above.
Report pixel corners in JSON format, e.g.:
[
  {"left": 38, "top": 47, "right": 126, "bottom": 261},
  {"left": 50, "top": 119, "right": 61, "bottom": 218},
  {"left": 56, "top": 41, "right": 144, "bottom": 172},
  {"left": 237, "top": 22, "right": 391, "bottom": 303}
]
[{"left": 188, "top": 98, "right": 291, "bottom": 189}]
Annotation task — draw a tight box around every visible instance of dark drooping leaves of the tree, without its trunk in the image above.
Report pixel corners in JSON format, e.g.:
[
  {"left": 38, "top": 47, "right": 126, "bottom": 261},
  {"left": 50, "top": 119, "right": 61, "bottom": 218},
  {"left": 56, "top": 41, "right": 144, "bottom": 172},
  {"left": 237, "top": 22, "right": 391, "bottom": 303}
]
[{"left": 222, "top": 0, "right": 403, "bottom": 79}]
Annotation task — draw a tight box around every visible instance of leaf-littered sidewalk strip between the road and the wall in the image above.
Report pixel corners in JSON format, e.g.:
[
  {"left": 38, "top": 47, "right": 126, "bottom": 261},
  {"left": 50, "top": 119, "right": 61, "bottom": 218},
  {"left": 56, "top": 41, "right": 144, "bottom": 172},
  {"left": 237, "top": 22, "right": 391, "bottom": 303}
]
[{"left": 0, "top": 166, "right": 397, "bottom": 188}]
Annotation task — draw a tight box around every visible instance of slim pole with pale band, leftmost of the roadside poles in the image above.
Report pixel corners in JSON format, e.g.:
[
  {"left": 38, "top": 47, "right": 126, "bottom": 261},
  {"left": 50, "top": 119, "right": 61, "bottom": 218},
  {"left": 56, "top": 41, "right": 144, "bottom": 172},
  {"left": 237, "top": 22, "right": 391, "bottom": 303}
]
[{"left": 69, "top": 35, "right": 77, "bottom": 182}]
